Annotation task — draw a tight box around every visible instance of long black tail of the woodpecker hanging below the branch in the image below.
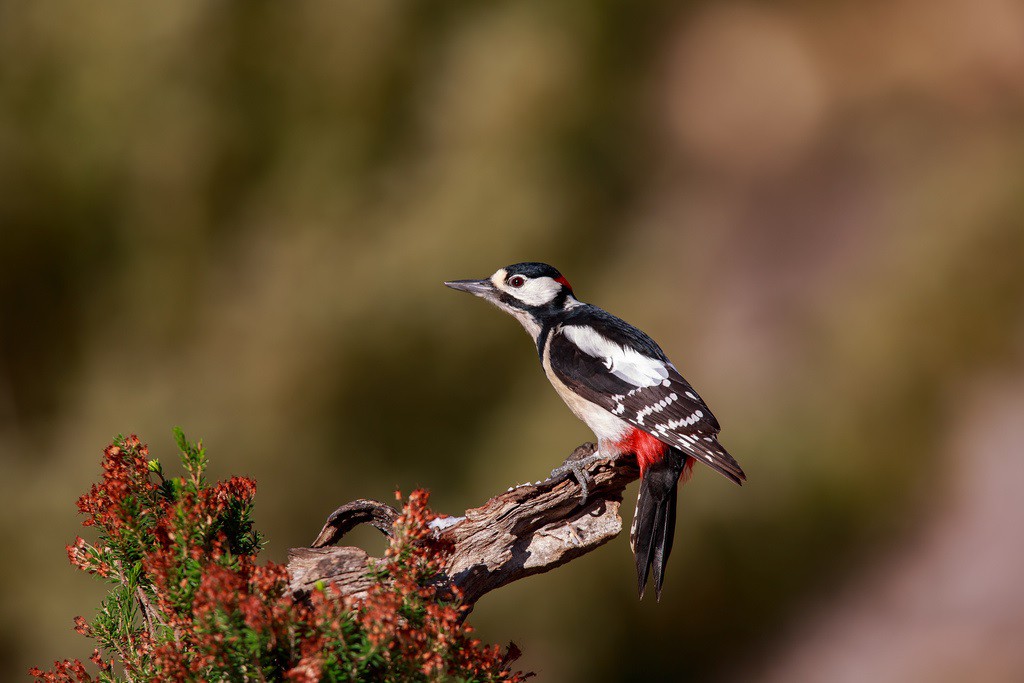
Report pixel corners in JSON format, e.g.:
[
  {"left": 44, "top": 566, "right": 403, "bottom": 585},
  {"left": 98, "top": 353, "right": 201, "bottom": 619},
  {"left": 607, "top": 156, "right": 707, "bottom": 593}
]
[{"left": 630, "top": 447, "right": 693, "bottom": 600}]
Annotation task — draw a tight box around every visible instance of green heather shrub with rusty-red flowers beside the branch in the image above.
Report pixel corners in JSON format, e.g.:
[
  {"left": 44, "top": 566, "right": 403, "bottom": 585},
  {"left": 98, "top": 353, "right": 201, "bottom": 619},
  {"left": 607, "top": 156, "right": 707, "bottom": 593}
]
[{"left": 30, "top": 436, "right": 526, "bottom": 682}]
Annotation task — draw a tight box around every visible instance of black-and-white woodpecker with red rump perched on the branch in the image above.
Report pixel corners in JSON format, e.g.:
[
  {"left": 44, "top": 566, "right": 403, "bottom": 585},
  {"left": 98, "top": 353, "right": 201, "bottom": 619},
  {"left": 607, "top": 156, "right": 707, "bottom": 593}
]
[{"left": 444, "top": 262, "right": 746, "bottom": 601}]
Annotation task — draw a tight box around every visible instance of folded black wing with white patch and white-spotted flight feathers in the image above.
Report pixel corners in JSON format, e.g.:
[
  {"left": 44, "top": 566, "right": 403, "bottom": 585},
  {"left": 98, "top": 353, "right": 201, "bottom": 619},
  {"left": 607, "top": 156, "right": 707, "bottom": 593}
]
[{"left": 548, "top": 311, "right": 746, "bottom": 483}]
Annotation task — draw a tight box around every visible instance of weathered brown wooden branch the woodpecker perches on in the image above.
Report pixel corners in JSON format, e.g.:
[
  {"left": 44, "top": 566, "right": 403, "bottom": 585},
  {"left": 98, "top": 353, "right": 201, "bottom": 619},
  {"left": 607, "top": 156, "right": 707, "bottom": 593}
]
[{"left": 288, "top": 443, "right": 640, "bottom": 605}]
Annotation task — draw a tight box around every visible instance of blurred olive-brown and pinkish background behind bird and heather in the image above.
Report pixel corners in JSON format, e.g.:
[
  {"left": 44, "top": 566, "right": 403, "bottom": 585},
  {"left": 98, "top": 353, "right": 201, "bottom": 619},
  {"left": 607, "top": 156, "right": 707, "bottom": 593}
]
[{"left": 0, "top": 0, "right": 1024, "bottom": 683}]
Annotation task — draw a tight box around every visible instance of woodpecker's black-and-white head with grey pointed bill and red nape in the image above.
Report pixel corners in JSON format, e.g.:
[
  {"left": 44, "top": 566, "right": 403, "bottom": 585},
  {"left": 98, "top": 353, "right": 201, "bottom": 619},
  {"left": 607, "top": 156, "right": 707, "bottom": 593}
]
[{"left": 444, "top": 262, "right": 580, "bottom": 339}]
